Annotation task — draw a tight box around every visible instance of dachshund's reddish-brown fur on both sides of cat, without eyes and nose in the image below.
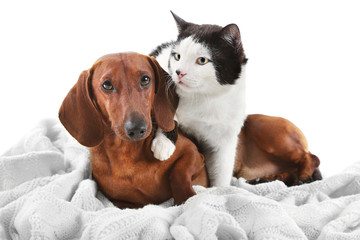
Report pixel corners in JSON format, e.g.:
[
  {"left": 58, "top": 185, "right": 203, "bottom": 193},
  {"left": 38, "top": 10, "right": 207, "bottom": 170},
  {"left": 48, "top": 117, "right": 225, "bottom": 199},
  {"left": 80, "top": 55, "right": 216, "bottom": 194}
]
[{"left": 59, "top": 53, "right": 321, "bottom": 208}]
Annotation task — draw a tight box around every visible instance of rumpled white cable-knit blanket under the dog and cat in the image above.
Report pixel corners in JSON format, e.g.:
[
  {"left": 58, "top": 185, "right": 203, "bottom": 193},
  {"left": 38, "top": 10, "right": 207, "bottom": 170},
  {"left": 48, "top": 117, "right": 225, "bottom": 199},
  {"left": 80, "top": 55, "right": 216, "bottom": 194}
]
[{"left": 0, "top": 120, "right": 360, "bottom": 240}]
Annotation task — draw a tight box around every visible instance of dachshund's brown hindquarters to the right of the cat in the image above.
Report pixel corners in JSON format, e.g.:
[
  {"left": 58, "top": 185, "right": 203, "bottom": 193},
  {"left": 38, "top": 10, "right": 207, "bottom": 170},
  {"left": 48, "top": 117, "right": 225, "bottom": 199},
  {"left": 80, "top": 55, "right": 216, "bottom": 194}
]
[{"left": 234, "top": 114, "right": 322, "bottom": 186}]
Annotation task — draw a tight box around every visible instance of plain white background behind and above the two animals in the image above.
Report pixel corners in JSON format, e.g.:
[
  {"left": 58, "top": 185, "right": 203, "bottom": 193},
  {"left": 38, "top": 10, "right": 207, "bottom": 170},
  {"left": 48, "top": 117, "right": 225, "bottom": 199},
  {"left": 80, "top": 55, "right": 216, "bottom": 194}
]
[{"left": 0, "top": 0, "right": 360, "bottom": 176}]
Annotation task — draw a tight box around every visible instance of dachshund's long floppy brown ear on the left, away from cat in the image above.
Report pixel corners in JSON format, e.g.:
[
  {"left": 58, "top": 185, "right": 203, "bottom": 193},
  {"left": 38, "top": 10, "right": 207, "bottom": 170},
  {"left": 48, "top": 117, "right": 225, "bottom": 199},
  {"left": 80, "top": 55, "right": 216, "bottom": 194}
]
[{"left": 59, "top": 71, "right": 104, "bottom": 147}]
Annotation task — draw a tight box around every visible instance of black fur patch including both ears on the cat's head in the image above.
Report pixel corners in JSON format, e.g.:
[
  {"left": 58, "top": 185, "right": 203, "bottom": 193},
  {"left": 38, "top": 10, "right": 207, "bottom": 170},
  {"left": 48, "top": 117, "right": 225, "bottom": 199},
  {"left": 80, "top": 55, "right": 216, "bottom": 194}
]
[{"left": 171, "top": 12, "right": 247, "bottom": 85}]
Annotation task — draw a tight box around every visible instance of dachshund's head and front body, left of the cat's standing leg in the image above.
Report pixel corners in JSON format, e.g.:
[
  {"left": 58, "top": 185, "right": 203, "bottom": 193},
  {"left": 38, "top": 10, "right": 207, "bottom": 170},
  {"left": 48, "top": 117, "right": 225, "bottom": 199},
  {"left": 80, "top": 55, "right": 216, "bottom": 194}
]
[{"left": 59, "top": 53, "right": 208, "bottom": 208}]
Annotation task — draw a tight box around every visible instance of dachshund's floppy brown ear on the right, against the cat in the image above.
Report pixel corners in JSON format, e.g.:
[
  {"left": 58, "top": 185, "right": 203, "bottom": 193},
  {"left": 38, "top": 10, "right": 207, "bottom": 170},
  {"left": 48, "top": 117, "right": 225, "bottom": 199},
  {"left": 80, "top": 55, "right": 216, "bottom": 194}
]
[{"left": 150, "top": 57, "right": 179, "bottom": 132}]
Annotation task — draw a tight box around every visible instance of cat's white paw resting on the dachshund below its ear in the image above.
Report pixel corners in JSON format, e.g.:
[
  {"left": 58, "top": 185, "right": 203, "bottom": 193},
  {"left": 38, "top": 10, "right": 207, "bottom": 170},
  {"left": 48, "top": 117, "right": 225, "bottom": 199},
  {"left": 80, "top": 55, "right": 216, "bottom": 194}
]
[{"left": 151, "top": 134, "right": 175, "bottom": 161}]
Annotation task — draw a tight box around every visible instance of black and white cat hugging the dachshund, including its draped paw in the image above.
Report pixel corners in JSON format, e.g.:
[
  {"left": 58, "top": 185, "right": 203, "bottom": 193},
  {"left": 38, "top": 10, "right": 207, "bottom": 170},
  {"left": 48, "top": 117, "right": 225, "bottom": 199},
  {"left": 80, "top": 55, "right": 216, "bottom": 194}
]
[{"left": 150, "top": 14, "right": 247, "bottom": 186}]
